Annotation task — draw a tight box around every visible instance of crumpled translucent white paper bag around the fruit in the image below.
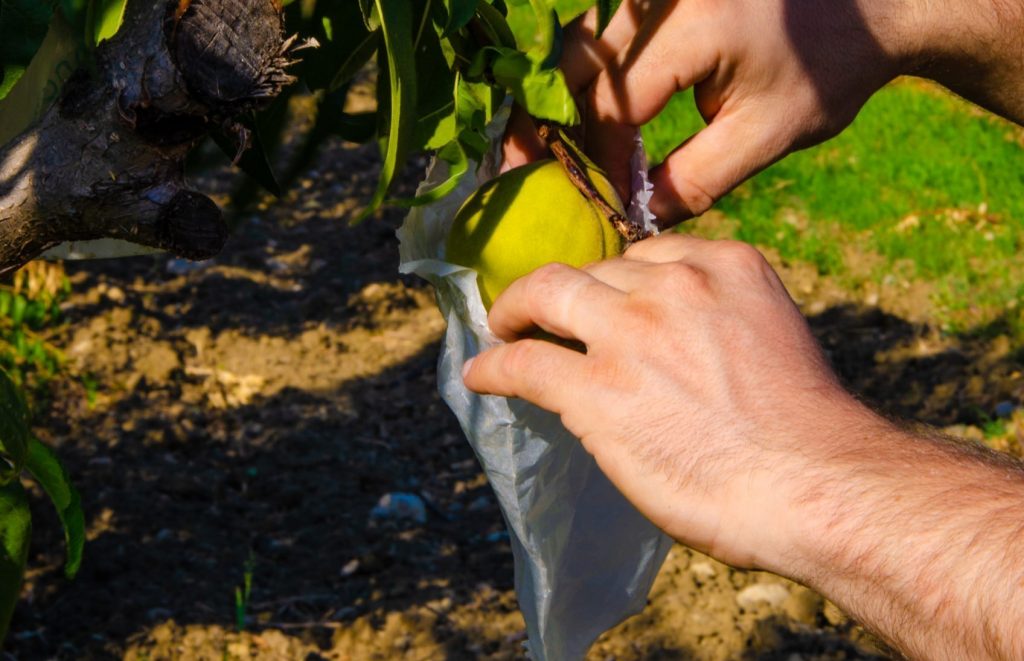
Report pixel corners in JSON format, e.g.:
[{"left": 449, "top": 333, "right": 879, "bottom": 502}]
[{"left": 397, "top": 108, "right": 672, "bottom": 661}]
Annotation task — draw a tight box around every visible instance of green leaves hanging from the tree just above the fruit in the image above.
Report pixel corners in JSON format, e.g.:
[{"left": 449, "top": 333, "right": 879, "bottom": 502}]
[{"left": 227, "top": 0, "right": 578, "bottom": 217}]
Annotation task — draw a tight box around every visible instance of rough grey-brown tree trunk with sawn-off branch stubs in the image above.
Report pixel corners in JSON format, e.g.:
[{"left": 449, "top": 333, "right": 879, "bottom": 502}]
[{"left": 0, "top": 0, "right": 292, "bottom": 273}]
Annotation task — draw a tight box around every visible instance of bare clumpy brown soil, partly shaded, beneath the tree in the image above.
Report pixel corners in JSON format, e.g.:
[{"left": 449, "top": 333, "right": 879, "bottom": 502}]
[{"left": 7, "top": 131, "right": 1024, "bottom": 661}]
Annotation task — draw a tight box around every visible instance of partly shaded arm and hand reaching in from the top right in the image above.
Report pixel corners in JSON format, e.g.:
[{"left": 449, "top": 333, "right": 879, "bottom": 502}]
[{"left": 506, "top": 0, "right": 1024, "bottom": 226}]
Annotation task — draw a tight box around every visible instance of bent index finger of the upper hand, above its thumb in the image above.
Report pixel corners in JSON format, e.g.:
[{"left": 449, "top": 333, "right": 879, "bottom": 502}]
[{"left": 587, "top": 20, "right": 717, "bottom": 126}]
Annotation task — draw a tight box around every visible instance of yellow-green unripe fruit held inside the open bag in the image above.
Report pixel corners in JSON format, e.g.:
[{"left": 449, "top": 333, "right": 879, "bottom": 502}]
[{"left": 445, "top": 160, "right": 625, "bottom": 310}]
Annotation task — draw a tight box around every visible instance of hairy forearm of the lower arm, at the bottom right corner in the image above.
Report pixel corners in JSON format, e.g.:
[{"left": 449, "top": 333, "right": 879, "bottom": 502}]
[{"left": 801, "top": 426, "right": 1024, "bottom": 659}]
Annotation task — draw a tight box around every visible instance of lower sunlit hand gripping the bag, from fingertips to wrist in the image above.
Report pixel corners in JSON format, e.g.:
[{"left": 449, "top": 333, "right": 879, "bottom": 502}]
[{"left": 464, "top": 234, "right": 879, "bottom": 575}]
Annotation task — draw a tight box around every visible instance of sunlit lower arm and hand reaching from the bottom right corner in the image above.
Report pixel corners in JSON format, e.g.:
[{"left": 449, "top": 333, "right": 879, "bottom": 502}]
[{"left": 465, "top": 235, "right": 1024, "bottom": 658}]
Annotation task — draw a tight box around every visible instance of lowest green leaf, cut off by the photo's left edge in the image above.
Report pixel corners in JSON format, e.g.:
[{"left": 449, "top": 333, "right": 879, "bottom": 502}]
[{"left": 0, "top": 480, "right": 32, "bottom": 643}]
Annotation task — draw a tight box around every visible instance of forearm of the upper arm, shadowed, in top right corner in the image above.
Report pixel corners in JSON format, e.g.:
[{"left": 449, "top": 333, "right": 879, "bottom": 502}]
[{"left": 905, "top": 0, "right": 1024, "bottom": 125}]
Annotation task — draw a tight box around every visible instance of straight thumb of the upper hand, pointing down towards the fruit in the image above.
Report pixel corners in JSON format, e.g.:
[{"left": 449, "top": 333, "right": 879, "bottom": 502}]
[{"left": 650, "top": 104, "right": 788, "bottom": 228}]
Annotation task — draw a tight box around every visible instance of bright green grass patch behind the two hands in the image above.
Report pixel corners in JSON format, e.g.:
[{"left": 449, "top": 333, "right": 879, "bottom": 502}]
[{"left": 643, "top": 82, "right": 1024, "bottom": 338}]
